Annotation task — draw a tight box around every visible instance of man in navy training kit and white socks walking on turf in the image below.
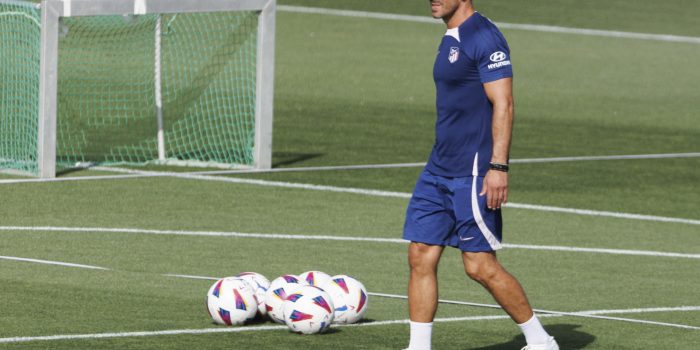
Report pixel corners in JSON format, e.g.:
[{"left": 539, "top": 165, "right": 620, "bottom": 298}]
[{"left": 403, "top": 0, "right": 559, "bottom": 350}]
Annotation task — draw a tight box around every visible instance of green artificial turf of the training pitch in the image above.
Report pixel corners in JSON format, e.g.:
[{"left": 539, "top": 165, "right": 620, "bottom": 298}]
[{"left": 0, "top": 0, "right": 700, "bottom": 350}]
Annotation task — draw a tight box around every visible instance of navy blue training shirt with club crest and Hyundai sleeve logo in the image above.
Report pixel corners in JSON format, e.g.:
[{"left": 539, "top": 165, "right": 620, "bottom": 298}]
[{"left": 426, "top": 12, "right": 513, "bottom": 177}]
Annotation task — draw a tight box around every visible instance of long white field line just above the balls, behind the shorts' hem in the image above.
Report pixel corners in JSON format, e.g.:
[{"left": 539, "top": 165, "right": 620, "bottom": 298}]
[{"left": 0, "top": 226, "right": 700, "bottom": 259}]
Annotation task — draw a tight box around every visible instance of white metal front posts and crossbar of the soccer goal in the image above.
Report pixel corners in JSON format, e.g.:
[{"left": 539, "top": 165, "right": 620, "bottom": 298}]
[{"left": 38, "top": 0, "right": 277, "bottom": 178}]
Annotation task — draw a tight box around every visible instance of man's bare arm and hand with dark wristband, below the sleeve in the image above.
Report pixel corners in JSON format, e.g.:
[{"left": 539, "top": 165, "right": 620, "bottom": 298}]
[{"left": 479, "top": 78, "right": 514, "bottom": 209}]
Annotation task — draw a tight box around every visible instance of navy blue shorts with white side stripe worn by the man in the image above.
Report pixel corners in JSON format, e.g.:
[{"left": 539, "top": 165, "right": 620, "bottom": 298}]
[{"left": 403, "top": 169, "right": 503, "bottom": 252}]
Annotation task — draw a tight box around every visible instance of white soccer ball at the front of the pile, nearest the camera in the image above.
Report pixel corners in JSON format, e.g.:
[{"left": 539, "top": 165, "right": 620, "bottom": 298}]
[{"left": 284, "top": 286, "right": 333, "bottom": 334}]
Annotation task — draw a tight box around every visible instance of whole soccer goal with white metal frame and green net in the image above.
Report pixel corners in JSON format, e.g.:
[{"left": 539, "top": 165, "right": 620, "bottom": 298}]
[{"left": 0, "top": 0, "right": 276, "bottom": 178}]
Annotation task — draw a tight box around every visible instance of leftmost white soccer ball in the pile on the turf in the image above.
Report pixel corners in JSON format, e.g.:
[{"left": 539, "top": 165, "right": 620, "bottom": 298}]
[{"left": 207, "top": 277, "right": 258, "bottom": 326}]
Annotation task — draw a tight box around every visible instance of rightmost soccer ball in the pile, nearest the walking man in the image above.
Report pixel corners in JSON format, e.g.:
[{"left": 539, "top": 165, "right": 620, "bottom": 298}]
[{"left": 321, "top": 275, "right": 368, "bottom": 323}]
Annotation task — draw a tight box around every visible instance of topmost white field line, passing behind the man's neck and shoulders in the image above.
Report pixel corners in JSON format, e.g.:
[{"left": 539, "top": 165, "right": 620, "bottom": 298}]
[{"left": 277, "top": 5, "right": 700, "bottom": 44}]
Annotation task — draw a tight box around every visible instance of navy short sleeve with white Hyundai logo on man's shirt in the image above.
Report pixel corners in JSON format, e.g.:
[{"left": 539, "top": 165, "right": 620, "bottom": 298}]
[{"left": 475, "top": 28, "right": 513, "bottom": 83}]
